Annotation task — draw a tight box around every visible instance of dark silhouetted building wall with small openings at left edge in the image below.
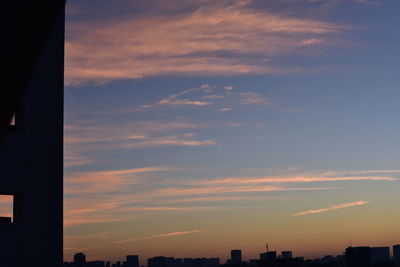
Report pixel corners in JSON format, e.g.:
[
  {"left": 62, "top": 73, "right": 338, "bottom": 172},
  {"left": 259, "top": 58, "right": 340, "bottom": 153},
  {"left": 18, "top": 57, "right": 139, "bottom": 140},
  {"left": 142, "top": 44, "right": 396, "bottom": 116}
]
[{"left": 0, "top": 0, "right": 65, "bottom": 267}]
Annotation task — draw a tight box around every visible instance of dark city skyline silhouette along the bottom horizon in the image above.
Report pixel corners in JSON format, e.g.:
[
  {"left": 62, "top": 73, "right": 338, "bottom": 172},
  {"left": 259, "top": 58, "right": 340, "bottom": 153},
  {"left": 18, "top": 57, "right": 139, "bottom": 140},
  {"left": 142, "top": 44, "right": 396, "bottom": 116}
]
[{"left": 64, "top": 245, "right": 400, "bottom": 267}]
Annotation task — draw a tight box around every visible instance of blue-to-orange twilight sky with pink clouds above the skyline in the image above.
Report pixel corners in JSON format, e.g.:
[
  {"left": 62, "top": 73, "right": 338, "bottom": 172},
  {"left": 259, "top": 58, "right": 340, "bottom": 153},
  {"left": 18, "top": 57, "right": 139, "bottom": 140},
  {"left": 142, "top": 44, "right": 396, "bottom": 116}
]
[{"left": 61, "top": 0, "right": 400, "bottom": 264}]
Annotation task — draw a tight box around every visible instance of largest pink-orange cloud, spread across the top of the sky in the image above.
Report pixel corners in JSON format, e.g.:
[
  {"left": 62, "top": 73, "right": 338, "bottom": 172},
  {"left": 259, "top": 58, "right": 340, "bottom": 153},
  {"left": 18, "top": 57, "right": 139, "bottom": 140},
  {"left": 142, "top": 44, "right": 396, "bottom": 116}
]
[{"left": 66, "top": 1, "right": 347, "bottom": 86}]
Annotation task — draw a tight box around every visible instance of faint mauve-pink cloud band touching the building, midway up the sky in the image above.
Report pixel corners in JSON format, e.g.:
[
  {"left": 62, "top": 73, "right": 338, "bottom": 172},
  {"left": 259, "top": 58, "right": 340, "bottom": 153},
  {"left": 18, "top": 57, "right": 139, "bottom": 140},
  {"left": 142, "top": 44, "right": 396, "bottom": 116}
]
[{"left": 64, "top": 120, "right": 219, "bottom": 167}]
